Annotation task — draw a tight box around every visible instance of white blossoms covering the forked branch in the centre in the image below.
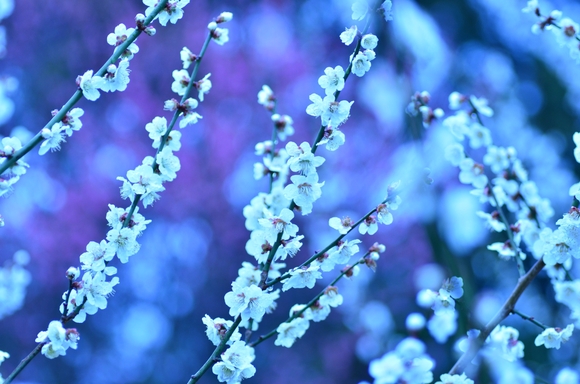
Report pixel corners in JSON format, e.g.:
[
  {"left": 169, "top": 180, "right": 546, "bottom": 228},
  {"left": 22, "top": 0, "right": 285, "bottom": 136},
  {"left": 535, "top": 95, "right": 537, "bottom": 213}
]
[{"left": 207, "top": 2, "right": 401, "bottom": 383}]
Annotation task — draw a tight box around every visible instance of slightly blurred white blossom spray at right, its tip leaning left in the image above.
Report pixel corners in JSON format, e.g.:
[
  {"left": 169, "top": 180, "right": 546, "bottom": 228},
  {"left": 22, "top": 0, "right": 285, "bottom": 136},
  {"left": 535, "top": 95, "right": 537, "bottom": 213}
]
[{"left": 442, "top": 92, "right": 554, "bottom": 266}]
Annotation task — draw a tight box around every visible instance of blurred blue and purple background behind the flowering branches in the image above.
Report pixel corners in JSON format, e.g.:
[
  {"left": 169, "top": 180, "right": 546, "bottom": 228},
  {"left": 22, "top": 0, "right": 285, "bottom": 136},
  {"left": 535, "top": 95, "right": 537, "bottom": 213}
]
[{"left": 0, "top": 0, "right": 580, "bottom": 384}]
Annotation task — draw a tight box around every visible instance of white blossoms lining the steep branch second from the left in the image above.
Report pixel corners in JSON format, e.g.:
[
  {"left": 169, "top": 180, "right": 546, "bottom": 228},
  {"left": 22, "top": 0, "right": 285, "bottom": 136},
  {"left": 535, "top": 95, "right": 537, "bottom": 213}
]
[{"left": 32, "top": 4, "right": 235, "bottom": 358}]
